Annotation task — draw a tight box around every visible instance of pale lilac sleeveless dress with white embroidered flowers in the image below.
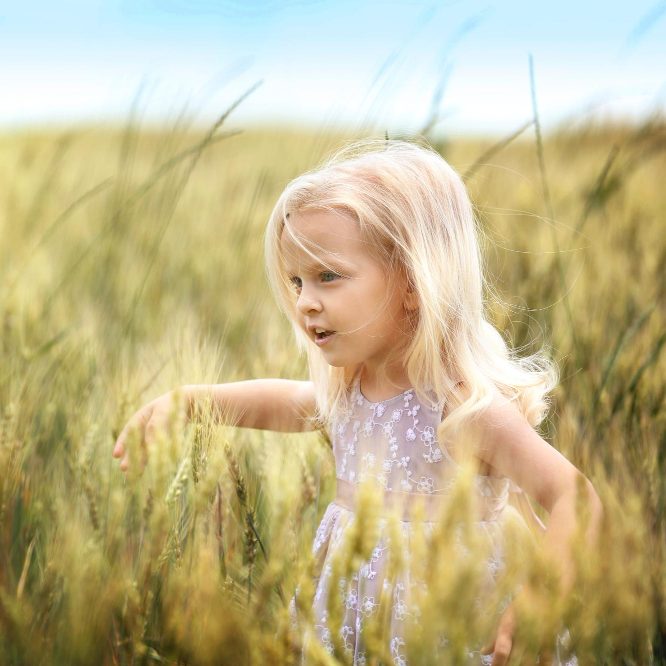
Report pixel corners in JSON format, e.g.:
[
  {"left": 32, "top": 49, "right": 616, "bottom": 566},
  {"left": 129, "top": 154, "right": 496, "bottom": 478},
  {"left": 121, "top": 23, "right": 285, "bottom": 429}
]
[{"left": 292, "top": 376, "right": 577, "bottom": 666}]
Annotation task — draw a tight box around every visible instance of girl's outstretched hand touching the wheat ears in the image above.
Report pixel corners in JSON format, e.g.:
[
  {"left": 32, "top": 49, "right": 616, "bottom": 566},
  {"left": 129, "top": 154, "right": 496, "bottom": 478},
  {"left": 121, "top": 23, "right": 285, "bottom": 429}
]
[{"left": 113, "top": 392, "right": 184, "bottom": 472}]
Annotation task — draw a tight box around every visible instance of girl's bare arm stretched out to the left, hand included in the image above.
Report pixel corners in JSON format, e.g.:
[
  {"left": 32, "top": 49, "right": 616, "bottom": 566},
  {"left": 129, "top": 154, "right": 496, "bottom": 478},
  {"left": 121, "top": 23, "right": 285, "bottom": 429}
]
[{"left": 113, "top": 379, "right": 315, "bottom": 471}]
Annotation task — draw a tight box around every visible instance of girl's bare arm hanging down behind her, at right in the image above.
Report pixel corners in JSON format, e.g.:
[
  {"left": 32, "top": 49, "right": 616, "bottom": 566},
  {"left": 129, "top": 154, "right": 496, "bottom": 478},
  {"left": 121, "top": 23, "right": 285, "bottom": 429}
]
[{"left": 477, "top": 398, "right": 603, "bottom": 594}]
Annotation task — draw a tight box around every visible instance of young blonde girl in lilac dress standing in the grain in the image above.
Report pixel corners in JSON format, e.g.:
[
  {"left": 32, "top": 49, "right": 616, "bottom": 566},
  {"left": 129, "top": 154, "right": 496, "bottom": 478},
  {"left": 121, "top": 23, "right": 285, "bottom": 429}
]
[{"left": 113, "top": 141, "right": 601, "bottom": 665}]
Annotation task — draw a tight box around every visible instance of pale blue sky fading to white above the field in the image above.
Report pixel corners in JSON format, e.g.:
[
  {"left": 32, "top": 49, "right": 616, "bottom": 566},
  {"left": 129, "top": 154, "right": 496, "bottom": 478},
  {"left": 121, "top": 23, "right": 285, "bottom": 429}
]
[{"left": 0, "top": 0, "right": 666, "bottom": 133}]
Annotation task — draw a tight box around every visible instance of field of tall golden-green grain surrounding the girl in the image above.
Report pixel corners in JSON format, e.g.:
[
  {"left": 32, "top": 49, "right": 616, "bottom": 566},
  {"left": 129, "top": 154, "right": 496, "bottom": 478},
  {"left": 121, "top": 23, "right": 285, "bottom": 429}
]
[{"left": 0, "top": 111, "right": 666, "bottom": 665}]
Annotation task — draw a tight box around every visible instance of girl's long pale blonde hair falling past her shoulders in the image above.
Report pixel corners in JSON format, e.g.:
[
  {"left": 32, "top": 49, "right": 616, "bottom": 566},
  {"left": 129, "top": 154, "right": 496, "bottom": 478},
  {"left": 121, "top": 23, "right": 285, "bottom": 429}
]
[{"left": 265, "top": 140, "right": 556, "bottom": 433}]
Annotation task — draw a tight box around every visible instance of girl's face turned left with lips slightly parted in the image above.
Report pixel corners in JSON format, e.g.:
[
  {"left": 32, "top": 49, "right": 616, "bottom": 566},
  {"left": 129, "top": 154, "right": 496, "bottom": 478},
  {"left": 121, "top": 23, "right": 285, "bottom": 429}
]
[{"left": 280, "top": 210, "right": 411, "bottom": 371}]
